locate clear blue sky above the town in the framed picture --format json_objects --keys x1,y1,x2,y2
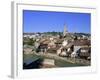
[{"x1": 23, "y1": 10, "x2": 91, "y2": 33}]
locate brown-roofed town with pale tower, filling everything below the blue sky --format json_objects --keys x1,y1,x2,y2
[{"x1": 23, "y1": 24, "x2": 91, "y2": 69}]
